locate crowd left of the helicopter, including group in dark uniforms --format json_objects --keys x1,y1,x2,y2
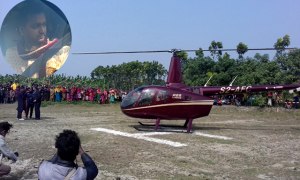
[{"x1": 0, "y1": 82, "x2": 127, "y2": 120}]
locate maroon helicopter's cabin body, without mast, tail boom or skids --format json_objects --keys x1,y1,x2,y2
[{"x1": 121, "y1": 86, "x2": 214, "y2": 120}]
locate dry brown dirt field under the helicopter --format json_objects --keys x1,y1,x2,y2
[{"x1": 0, "y1": 103, "x2": 300, "y2": 180}]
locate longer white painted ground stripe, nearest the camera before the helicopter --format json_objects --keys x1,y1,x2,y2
[{"x1": 91, "y1": 128, "x2": 187, "y2": 147}]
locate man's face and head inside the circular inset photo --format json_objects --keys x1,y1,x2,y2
[{"x1": 19, "y1": 13, "x2": 47, "y2": 48}]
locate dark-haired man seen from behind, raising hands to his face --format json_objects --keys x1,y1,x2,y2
[{"x1": 38, "y1": 130, "x2": 98, "y2": 180}]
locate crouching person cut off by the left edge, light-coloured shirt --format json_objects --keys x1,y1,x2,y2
[{"x1": 0, "y1": 122, "x2": 19, "y2": 177}]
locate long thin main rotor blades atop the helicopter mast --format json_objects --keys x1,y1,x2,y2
[{"x1": 72, "y1": 48, "x2": 295, "y2": 55}]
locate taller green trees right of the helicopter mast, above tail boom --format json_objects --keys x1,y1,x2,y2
[{"x1": 179, "y1": 35, "x2": 300, "y2": 86}]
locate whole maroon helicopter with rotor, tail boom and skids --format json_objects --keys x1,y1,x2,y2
[{"x1": 74, "y1": 48, "x2": 300, "y2": 133}]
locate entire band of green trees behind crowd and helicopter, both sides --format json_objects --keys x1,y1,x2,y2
[{"x1": 0, "y1": 35, "x2": 300, "y2": 91}]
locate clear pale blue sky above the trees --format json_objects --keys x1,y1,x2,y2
[{"x1": 0, "y1": 0, "x2": 300, "y2": 76}]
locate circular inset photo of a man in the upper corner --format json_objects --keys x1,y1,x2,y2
[{"x1": 0, "y1": 0, "x2": 72, "y2": 78}]
